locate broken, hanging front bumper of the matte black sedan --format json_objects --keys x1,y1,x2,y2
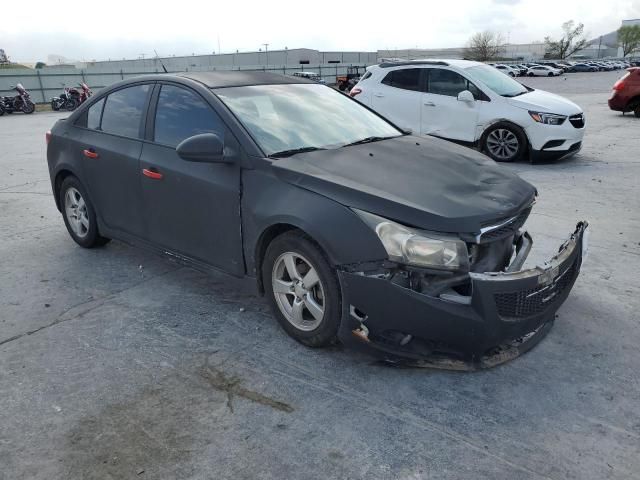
[{"x1": 339, "y1": 222, "x2": 588, "y2": 370}]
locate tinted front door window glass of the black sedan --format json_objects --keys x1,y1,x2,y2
[{"x1": 154, "y1": 85, "x2": 222, "y2": 147}]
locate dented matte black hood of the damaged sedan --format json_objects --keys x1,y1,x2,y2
[{"x1": 272, "y1": 136, "x2": 535, "y2": 233}]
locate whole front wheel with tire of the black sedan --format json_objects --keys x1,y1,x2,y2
[{"x1": 262, "y1": 230, "x2": 342, "y2": 347}]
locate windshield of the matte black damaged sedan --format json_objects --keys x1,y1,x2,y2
[{"x1": 214, "y1": 84, "x2": 402, "y2": 155}]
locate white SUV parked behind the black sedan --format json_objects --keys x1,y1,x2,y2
[{"x1": 350, "y1": 60, "x2": 584, "y2": 162}]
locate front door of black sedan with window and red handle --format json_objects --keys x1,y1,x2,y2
[{"x1": 140, "y1": 83, "x2": 244, "y2": 275}]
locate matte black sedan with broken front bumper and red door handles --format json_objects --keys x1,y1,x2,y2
[{"x1": 47, "y1": 70, "x2": 587, "y2": 368}]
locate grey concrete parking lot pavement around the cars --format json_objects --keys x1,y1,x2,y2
[{"x1": 0, "y1": 71, "x2": 640, "y2": 480}]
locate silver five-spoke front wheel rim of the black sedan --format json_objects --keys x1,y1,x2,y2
[{"x1": 271, "y1": 252, "x2": 325, "y2": 332}]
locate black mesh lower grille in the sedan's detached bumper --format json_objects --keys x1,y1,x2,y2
[{"x1": 494, "y1": 258, "x2": 578, "y2": 321}]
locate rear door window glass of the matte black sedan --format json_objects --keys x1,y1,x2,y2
[{"x1": 102, "y1": 85, "x2": 151, "y2": 138}]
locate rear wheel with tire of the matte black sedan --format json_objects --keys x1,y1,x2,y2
[{"x1": 59, "y1": 176, "x2": 109, "y2": 248}]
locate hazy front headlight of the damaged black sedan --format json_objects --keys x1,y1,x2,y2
[{"x1": 354, "y1": 209, "x2": 469, "y2": 271}]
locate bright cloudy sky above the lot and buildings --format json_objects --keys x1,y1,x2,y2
[{"x1": 0, "y1": 0, "x2": 640, "y2": 62}]
